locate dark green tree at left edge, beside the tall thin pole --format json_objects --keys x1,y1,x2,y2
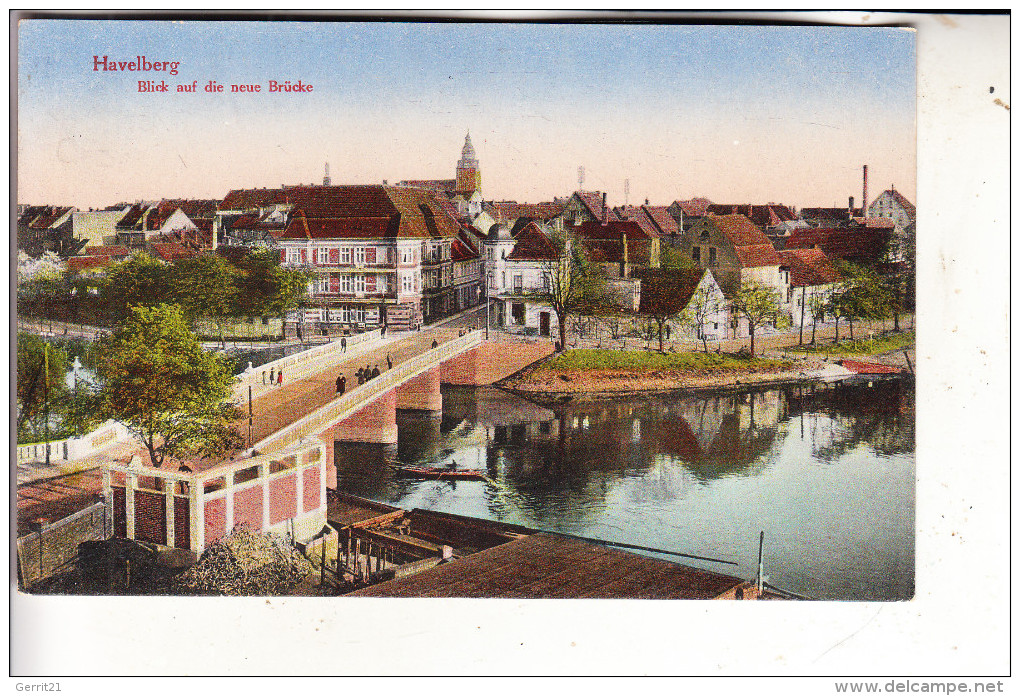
[{"x1": 17, "y1": 333, "x2": 67, "y2": 440}]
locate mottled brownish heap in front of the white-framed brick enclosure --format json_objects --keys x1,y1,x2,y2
[{"x1": 173, "y1": 525, "x2": 311, "y2": 596}]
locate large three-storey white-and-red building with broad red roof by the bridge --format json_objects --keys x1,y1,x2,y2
[{"x1": 277, "y1": 185, "x2": 466, "y2": 332}]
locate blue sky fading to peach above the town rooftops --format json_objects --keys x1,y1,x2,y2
[{"x1": 17, "y1": 19, "x2": 916, "y2": 209}]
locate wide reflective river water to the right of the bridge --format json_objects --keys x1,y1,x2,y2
[{"x1": 336, "y1": 381, "x2": 915, "y2": 600}]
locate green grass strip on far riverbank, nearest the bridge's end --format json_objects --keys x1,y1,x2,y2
[{"x1": 534, "y1": 349, "x2": 792, "y2": 377}]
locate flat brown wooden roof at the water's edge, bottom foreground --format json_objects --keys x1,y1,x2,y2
[{"x1": 348, "y1": 533, "x2": 744, "y2": 599}]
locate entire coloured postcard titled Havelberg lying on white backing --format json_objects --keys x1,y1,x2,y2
[{"x1": 11, "y1": 15, "x2": 1008, "y2": 674}]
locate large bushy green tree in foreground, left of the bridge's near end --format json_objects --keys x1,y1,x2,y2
[{"x1": 100, "y1": 304, "x2": 243, "y2": 466}]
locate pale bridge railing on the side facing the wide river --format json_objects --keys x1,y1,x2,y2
[{"x1": 252, "y1": 330, "x2": 486, "y2": 452}]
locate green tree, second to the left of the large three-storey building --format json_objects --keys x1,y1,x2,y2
[{"x1": 169, "y1": 254, "x2": 239, "y2": 348}]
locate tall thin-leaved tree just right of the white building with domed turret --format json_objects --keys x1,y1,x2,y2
[{"x1": 537, "y1": 231, "x2": 607, "y2": 350}]
